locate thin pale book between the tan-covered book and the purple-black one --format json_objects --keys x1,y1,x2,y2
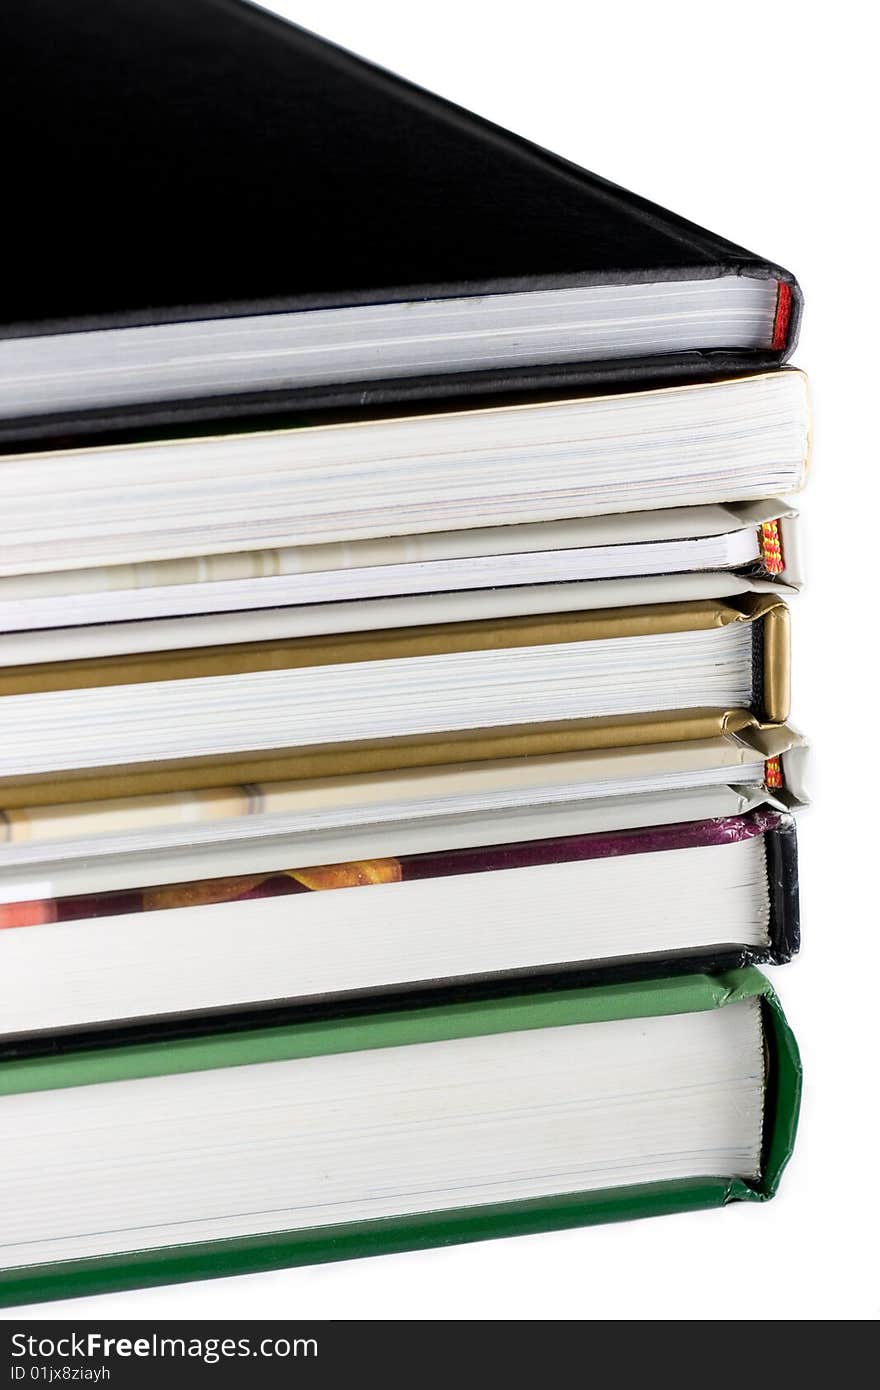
[{"x1": 0, "y1": 716, "x2": 808, "y2": 884}]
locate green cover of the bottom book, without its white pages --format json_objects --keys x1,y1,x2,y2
[{"x1": 0, "y1": 967, "x2": 801, "y2": 1307}]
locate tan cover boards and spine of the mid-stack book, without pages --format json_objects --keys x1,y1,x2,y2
[{"x1": 0, "y1": 595, "x2": 790, "y2": 810}]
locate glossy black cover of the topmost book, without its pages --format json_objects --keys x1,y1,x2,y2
[{"x1": 0, "y1": 0, "x2": 799, "y2": 438}]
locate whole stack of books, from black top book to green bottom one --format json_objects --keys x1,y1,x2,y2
[{"x1": 0, "y1": 0, "x2": 809, "y2": 1301}]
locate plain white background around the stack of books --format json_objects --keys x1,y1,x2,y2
[{"x1": 10, "y1": 0, "x2": 880, "y2": 1321}]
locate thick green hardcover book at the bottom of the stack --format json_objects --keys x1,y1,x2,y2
[{"x1": 0, "y1": 969, "x2": 801, "y2": 1304}]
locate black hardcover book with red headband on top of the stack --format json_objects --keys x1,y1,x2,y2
[{"x1": 0, "y1": 0, "x2": 801, "y2": 438}]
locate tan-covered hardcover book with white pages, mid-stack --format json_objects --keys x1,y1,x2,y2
[{"x1": 0, "y1": 595, "x2": 790, "y2": 808}]
